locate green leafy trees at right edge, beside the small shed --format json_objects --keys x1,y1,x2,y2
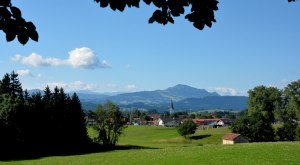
[{"x1": 231, "y1": 80, "x2": 300, "y2": 142}]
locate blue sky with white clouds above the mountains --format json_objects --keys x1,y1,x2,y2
[{"x1": 0, "y1": 0, "x2": 300, "y2": 95}]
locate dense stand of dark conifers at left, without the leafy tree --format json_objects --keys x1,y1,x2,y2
[{"x1": 0, "y1": 72, "x2": 88, "y2": 149}]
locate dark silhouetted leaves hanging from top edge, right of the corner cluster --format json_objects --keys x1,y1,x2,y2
[{"x1": 95, "y1": 0, "x2": 295, "y2": 30}]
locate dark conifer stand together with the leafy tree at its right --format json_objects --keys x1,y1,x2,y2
[{"x1": 0, "y1": 71, "x2": 125, "y2": 156}]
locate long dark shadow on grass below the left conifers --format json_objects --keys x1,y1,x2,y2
[{"x1": 0, "y1": 143, "x2": 158, "y2": 162}]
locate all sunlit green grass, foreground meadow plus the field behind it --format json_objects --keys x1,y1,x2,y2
[{"x1": 0, "y1": 126, "x2": 300, "y2": 165}]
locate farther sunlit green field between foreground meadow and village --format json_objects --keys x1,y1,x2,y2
[{"x1": 119, "y1": 126, "x2": 229, "y2": 148}]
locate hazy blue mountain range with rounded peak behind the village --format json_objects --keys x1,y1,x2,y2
[{"x1": 29, "y1": 84, "x2": 248, "y2": 112}]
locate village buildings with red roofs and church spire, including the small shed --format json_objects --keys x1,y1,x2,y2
[{"x1": 86, "y1": 101, "x2": 249, "y2": 144}]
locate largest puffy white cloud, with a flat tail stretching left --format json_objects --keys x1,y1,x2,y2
[{"x1": 11, "y1": 47, "x2": 111, "y2": 69}]
